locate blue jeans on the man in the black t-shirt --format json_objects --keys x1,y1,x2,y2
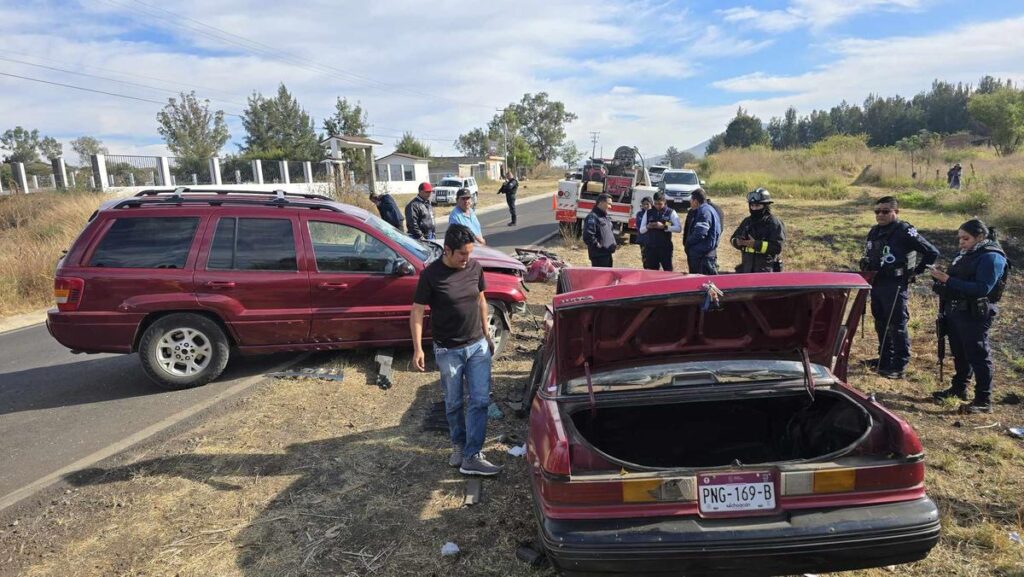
[{"x1": 434, "y1": 338, "x2": 490, "y2": 457}]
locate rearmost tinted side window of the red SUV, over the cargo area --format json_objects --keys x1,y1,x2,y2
[{"x1": 89, "y1": 216, "x2": 199, "y2": 269}]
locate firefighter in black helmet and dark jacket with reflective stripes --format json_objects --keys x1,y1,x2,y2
[{"x1": 729, "y1": 189, "x2": 785, "y2": 273}]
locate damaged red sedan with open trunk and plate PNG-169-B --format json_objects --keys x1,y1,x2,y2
[{"x1": 527, "y1": 269, "x2": 939, "y2": 575}]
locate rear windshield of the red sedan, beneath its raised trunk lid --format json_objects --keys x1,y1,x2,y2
[{"x1": 565, "y1": 359, "x2": 831, "y2": 395}]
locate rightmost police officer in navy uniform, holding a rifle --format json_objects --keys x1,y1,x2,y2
[{"x1": 931, "y1": 218, "x2": 1011, "y2": 414}]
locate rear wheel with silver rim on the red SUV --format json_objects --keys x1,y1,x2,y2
[{"x1": 138, "y1": 313, "x2": 230, "y2": 390}]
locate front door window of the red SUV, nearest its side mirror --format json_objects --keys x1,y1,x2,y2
[{"x1": 309, "y1": 222, "x2": 398, "y2": 273}]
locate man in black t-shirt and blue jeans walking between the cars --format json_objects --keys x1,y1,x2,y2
[{"x1": 409, "y1": 224, "x2": 502, "y2": 477}]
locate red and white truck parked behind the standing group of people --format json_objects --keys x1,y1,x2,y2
[{"x1": 554, "y1": 147, "x2": 657, "y2": 242}]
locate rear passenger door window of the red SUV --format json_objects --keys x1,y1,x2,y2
[{"x1": 207, "y1": 218, "x2": 298, "y2": 271}]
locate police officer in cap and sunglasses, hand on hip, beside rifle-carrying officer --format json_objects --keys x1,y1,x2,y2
[{"x1": 860, "y1": 197, "x2": 939, "y2": 379}]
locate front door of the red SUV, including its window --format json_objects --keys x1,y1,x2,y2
[{"x1": 303, "y1": 215, "x2": 419, "y2": 345}]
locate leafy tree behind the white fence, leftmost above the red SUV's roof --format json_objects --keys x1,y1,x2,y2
[{"x1": 157, "y1": 91, "x2": 231, "y2": 162}]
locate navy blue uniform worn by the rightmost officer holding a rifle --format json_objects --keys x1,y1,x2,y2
[{"x1": 942, "y1": 241, "x2": 1007, "y2": 405}]
